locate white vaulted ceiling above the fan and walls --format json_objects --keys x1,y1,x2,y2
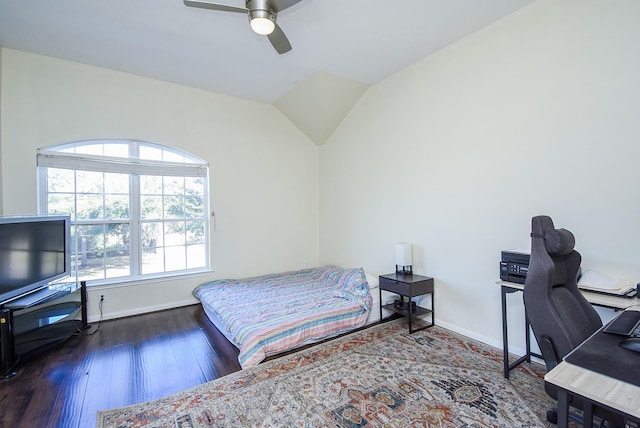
[{"x1": 0, "y1": 0, "x2": 533, "y2": 144}]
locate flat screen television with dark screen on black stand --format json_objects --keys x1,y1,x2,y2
[{"x1": 0, "y1": 216, "x2": 71, "y2": 303}]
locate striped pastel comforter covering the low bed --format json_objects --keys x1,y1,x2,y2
[{"x1": 193, "y1": 266, "x2": 372, "y2": 368}]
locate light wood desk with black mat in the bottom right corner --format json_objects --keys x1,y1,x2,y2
[{"x1": 544, "y1": 308, "x2": 640, "y2": 428}]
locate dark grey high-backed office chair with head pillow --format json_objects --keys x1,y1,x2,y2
[{"x1": 524, "y1": 216, "x2": 619, "y2": 426}]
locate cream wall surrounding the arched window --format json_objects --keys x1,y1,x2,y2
[{"x1": 0, "y1": 49, "x2": 318, "y2": 319}]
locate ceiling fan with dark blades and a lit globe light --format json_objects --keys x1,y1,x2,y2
[{"x1": 183, "y1": 0, "x2": 302, "y2": 54}]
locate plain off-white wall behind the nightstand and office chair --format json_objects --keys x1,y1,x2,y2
[{"x1": 320, "y1": 0, "x2": 640, "y2": 349}]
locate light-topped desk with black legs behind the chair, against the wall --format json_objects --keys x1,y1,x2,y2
[{"x1": 496, "y1": 281, "x2": 640, "y2": 379}]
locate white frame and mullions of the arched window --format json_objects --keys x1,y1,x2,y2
[{"x1": 37, "y1": 139, "x2": 211, "y2": 285}]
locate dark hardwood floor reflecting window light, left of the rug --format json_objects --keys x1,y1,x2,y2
[{"x1": 0, "y1": 305, "x2": 240, "y2": 428}]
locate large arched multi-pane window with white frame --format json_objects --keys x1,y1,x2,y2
[{"x1": 37, "y1": 140, "x2": 209, "y2": 283}]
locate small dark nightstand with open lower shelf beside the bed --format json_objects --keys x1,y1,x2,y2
[{"x1": 379, "y1": 273, "x2": 436, "y2": 334}]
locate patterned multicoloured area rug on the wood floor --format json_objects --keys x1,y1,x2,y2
[{"x1": 97, "y1": 320, "x2": 553, "y2": 428}]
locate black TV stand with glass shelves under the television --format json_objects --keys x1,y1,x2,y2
[{"x1": 0, "y1": 281, "x2": 89, "y2": 379}]
